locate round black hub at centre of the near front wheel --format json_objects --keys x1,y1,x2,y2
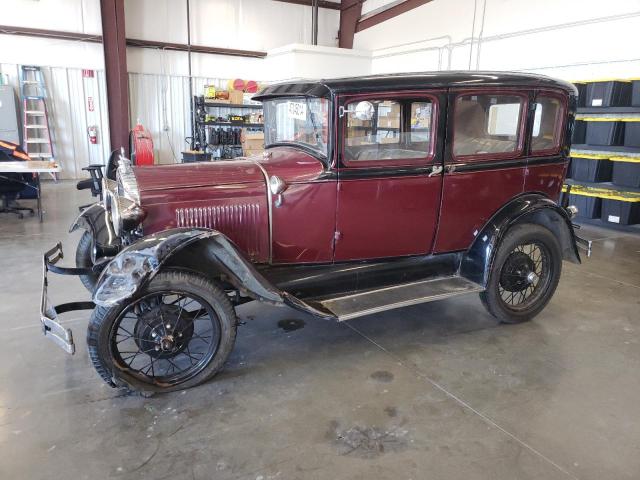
[{"x1": 134, "y1": 304, "x2": 193, "y2": 358}]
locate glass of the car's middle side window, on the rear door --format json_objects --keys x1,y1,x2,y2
[{"x1": 453, "y1": 94, "x2": 524, "y2": 157}]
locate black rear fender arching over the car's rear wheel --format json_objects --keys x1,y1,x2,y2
[{"x1": 460, "y1": 193, "x2": 581, "y2": 286}]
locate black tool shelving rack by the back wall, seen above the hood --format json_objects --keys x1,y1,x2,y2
[{"x1": 193, "y1": 96, "x2": 264, "y2": 160}]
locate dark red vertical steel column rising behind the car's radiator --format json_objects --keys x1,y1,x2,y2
[{"x1": 100, "y1": 0, "x2": 129, "y2": 156}]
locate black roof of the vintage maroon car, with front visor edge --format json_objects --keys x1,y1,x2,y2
[{"x1": 253, "y1": 71, "x2": 578, "y2": 100}]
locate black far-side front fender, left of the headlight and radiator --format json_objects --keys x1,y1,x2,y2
[{"x1": 69, "y1": 202, "x2": 121, "y2": 263}]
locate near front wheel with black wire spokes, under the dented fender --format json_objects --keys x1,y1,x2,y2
[{"x1": 87, "y1": 270, "x2": 237, "y2": 392}]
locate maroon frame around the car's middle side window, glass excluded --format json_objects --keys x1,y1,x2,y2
[{"x1": 449, "y1": 88, "x2": 531, "y2": 163}]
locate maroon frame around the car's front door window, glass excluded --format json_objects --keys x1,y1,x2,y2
[{"x1": 339, "y1": 90, "x2": 442, "y2": 170}]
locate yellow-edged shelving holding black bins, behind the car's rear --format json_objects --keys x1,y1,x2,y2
[{"x1": 564, "y1": 78, "x2": 640, "y2": 232}]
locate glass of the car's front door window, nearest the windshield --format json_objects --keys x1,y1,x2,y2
[{"x1": 344, "y1": 99, "x2": 433, "y2": 163}]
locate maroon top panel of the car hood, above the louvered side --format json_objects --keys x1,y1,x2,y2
[{"x1": 134, "y1": 159, "x2": 265, "y2": 194}]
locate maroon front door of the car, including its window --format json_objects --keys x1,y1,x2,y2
[{"x1": 334, "y1": 91, "x2": 445, "y2": 261}]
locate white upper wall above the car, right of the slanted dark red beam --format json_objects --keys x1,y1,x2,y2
[{"x1": 354, "y1": 0, "x2": 640, "y2": 80}]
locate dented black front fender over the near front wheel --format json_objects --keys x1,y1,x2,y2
[{"x1": 93, "y1": 228, "x2": 283, "y2": 306}]
